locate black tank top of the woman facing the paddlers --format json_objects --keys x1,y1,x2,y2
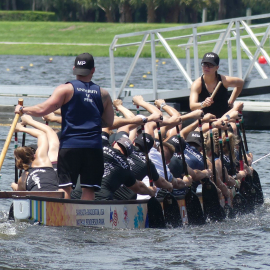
[{"x1": 199, "y1": 74, "x2": 229, "y2": 118}]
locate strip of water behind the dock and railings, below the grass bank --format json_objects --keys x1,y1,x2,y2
[{"x1": 0, "y1": 55, "x2": 270, "y2": 97}]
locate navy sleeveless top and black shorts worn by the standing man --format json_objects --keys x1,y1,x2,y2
[{"x1": 57, "y1": 80, "x2": 104, "y2": 190}]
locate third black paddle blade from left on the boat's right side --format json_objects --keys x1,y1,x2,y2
[{"x1": 185, "y1": 188, "x2": 205, "y2": 225}]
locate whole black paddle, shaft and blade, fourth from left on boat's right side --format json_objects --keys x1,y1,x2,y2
[{"x1": 200, "y1": 122, "x2": 226, "y2": 221}]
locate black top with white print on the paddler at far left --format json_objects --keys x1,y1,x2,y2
[{"x1": 26, "y1": 167, "x2": 59, "y2": 191}]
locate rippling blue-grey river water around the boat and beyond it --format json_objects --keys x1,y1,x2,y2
[{"x1": 0, "y1": 56, "x2": 270, "y2": 270}]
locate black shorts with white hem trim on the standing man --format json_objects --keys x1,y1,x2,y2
[{"x1": 57, "y1": 148, "x2": 104, "y2": 191}]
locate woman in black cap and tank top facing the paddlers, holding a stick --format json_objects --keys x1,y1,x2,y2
[{"x1": 189, "y1": 52, "x2": 244, "y2": 118}]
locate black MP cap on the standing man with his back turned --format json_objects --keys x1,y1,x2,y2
[{"x1": 73, "y1": 53, "x2": 95, "y2": 76}]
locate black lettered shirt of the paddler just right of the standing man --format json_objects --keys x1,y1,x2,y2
[{"x1": 95, "y1": 146, "x2": 136, "y2": 200}]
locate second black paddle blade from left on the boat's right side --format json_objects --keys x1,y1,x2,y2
[{"x1": 163, "y1": 193, "x2": 183, "y2": 228}]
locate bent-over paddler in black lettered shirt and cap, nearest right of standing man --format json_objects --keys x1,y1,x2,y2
[{"x1": 96, "y1": 137, "x2": 156, "y2": 200}]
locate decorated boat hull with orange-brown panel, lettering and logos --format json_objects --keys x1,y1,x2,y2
[{"x1": 13, "y1": 194, "x2": 193, "y2": 229}]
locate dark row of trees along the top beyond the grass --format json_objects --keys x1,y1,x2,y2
[{"x1": 0, "y1": 0, "x2": 270, "y2": 23}]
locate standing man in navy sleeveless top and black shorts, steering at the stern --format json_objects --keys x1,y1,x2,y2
[{"x1": 15, "y1": 53, "x2": 114, "y2": 200}]
